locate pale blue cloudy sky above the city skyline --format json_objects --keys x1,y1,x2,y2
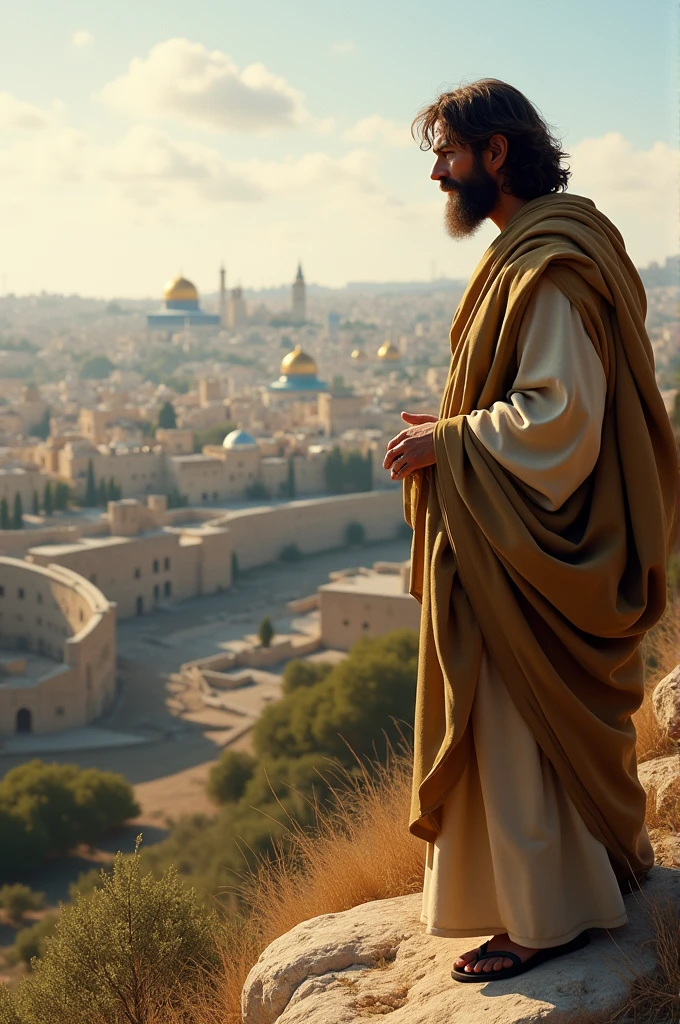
[{"x1": 0, "y1": 0, "x2": 678, "y2": 298}]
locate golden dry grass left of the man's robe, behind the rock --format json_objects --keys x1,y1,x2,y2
[{"x1": 167, "y1": 750, "x2": 424, "y2": 1024}]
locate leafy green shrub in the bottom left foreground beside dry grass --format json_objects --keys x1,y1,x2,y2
[{"x1": 5, "y1": 841, "x2": 219, "y2": 1024}]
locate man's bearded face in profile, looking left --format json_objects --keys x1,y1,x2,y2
[{"x1": 430, "y1": 136, "x2": 500, "y2": 239}]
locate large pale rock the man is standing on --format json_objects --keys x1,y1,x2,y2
[{"x1": 242, "y1": 867, "x2": 680, "y2": 1024}]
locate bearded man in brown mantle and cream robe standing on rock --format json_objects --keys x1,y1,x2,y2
[{"x1": 384, "y1": 80, "x2": 678, "y2": 981}]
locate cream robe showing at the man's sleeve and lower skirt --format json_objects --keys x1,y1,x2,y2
[{"x1": 421, "y1": 280, "x2": 648, "y2": 948}]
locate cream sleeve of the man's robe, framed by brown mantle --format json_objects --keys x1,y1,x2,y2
[{"x1": 467, "y1": 279, "x2": 606, "y2": 511}]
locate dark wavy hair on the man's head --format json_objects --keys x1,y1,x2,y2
[{"x1": 411, "y1": 78, "x2": 570, "y2": 200}]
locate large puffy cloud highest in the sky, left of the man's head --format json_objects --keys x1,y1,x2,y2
[{"x1": 100, "y1": 39, "x2": 308, "y2": 131}]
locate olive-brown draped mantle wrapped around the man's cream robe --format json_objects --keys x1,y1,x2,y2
[{"x1": 405, "y1": 195, "x2": 678, "y2": 882}]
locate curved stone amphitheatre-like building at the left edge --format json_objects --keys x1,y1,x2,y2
[{"x1": 0, "y1": 557, "x2": 116, "y2": 736}]
